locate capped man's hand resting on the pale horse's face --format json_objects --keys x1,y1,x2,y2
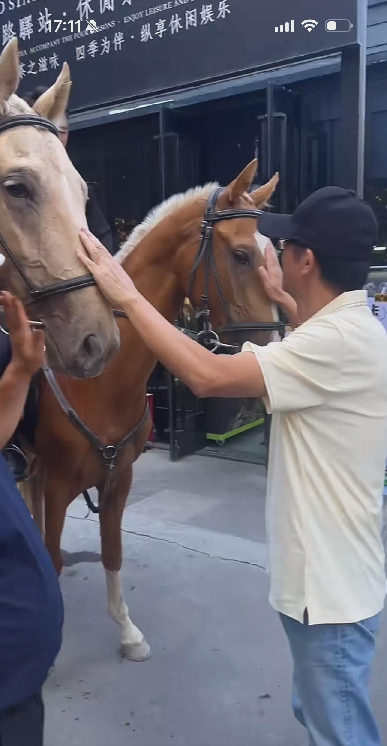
[{"x1": 78, "y1": 229, "x2": 138, "y2": 308}]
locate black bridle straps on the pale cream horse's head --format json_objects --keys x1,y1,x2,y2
[{"x1": 0, "y1": 115, "x2": 95, "y2": 306}]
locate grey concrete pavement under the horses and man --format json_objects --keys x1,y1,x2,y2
[{"x1": 45, "y1": 451, "x2": 387, "y2": 746}]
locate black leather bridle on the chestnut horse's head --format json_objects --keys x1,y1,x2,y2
[{"x1": 189, "y1": 187, "x2": 285, "y2": 351}]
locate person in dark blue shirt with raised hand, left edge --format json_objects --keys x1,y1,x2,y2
[{"x1": 0, "y1": 293, "x2": 63, "y2": 746}]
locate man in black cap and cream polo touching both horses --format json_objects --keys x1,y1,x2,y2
[{"x1": 81, "y1": 187, "x2": 387, "y2": 746}]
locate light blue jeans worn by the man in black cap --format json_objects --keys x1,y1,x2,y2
[{"x1": 280, "y1": 614, "x2": 382, "y2": 746}]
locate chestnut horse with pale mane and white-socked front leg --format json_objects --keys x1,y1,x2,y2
[{"x1": 28, "y1": 161, "x2": 278, "y2": 661}]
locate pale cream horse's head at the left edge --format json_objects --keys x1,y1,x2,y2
[{"x1": 0, "y1": 39, "x2": 119, "y2": 378}]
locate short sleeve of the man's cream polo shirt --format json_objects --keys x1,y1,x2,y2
[{"x1": 242, "y1": 319, "x2": 344, "y2": 414}]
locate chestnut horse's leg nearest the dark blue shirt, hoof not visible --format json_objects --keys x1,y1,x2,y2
[{"x1": 44, "y1": 479, "x2": 71, "y2": 575}]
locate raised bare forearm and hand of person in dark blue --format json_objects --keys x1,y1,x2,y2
[{"x1": 0, "y1": 293, "x2": 44, "y2": 450}]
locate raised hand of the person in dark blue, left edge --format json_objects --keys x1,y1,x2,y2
[{"x1": 0, "y1": 291, "x2": 46, "y2": 377}]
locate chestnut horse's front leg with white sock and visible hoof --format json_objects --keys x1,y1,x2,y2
[{"x1": 99, "y1": 466, "x2": 151, "y2": 661}]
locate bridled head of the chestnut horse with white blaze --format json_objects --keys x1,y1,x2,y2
[{"x1": 180, "y1": 160, "x2": 278, "y2": 343}]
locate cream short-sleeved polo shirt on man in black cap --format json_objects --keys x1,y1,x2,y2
[{"x1": 243, "y1": 290, "x2": 387, "y2": 624}]
